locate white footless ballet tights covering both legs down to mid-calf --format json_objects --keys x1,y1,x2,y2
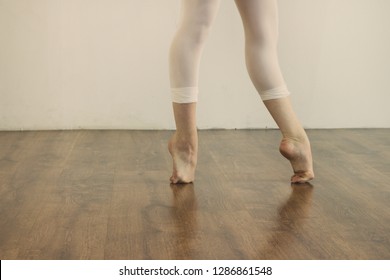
[{"x1": 170, "y1": 0, "x2": 289, "y2": 103}]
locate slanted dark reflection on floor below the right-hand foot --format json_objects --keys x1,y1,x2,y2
[{"x1": 258, "y1": 183, "x2": 313, "y2": 259}]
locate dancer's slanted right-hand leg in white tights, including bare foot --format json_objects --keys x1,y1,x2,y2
[{"x1": 235, "y1": 0, "x2": 314, "y2": 183}]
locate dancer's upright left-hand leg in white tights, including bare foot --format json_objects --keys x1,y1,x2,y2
[{"x1": 168, "y1": 0, "x2": 220, "y2": 184}]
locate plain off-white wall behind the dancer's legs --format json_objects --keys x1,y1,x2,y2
[{"x1": 0, "y1": 0, "x2": 390, "y2": 130}]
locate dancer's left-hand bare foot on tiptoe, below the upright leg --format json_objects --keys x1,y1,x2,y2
[{"x1": 168, "y1": 133, "x2": 197, "y2": 184}]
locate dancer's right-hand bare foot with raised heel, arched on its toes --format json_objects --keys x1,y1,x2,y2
[{"x1": 279, "y1": 138, "x2": 314, "y2": 183}]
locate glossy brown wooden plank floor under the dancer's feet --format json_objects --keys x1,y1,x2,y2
[{"x1": 0, "y1": 129, "x2": 390, "y2": 259}]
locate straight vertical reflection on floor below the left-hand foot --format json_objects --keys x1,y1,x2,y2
[{"x1": 171, "y1": 184, "x2": 198, "y2": 259}]
